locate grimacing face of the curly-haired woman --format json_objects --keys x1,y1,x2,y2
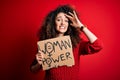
[{"x1": 55, "y1": 12, "x2": 69, "y2": 35}]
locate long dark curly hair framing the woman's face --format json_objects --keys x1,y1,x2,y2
[{"x1": 38, "y1": 5, "x2": 80, "y2": 47}]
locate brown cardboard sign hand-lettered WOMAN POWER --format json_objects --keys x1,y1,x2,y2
[{"x1": 37, "y1": 36, "x2": 74, "y2": 70}]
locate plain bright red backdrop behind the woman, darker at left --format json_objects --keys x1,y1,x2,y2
[{"x1": 0, "y1": 0, "x2": 120, "y2": 80}]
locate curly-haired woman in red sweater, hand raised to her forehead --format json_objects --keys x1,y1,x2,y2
[{"x1": 31, "y1": 5, "x2": 102, "y2": 80}]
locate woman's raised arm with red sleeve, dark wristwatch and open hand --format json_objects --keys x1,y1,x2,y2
[{"x1": 66, "y1": 11, "x2": 103, "y2": 55}]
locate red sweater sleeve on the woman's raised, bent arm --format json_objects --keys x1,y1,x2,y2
[{"x1": 80, "y1": 39, "x2": 103, "y2": 55}]
